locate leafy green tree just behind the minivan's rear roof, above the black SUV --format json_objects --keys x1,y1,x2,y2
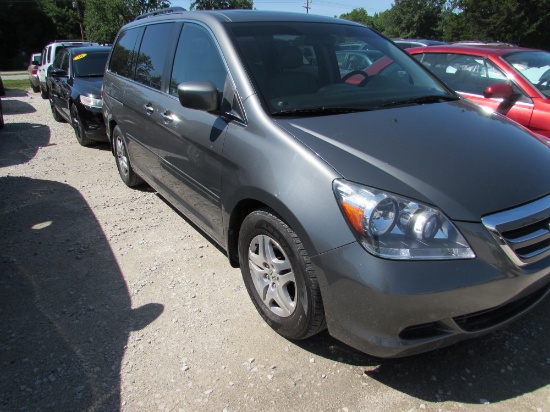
[{"x1": 84, "y1": 0, "x2": 170, "y2": 43}]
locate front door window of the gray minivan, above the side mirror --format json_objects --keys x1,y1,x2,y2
[{"x1": 170, "y1": 24, "x2": 227, "y2": 96}]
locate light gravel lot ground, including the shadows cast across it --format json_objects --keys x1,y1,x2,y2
[{"x1": 0, "y1": 91, "x2": 550, "y2": 412}]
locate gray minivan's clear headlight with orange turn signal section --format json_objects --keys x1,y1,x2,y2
[{"x1": 334, "y1": 180, "x2": 475, "y2": 260}]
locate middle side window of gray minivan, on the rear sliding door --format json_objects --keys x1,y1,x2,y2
[{"x1": 135, "y1": 23, "x2": 175, "y2": 90}]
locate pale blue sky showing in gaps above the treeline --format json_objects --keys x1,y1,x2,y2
[{"x1": 171, "y1": 0, "x2": 393, "y2": 17}]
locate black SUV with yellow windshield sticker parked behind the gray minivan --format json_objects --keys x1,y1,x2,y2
[{"x1": 48, "y1": 46, "x2": 111, "y2": 146}]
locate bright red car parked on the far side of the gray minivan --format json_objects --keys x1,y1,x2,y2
[{"x1": 408, "y1": 45, "x2": 550, "y2": 139}]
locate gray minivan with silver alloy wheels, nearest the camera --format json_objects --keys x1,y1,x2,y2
[{"x1": 103, "y1": 9, "x2": 550, "y2": 357}]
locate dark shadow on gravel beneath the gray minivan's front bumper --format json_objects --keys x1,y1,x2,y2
[{"x1": 297, "y1": 298, "x2": 550, "y2": 405}]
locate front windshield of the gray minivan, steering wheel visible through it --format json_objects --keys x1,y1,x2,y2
[{"x1": 229, "y1": 22, "x2": 458, "y2": 116}]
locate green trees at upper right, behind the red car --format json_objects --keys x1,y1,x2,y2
[{"x1": 340, "y1": 0, "x2": 550, "y2": 49}]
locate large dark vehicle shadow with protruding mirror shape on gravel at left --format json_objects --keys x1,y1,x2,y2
[{"x1": 0, "y1": 176, "x2": 163, "y2": 411}]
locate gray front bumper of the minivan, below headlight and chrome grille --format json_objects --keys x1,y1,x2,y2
[{"x1": 312, "y1": 220, "x2": 550, "y2": 357}]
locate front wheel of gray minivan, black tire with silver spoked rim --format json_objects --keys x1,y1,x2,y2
[{"x1": 239, "y1": 209, "x2": 326, "y2": 340}]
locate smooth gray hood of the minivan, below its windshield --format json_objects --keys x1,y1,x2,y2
[{"x1": 277, "y1": 100, "x2": 550, "y2": 221}]
